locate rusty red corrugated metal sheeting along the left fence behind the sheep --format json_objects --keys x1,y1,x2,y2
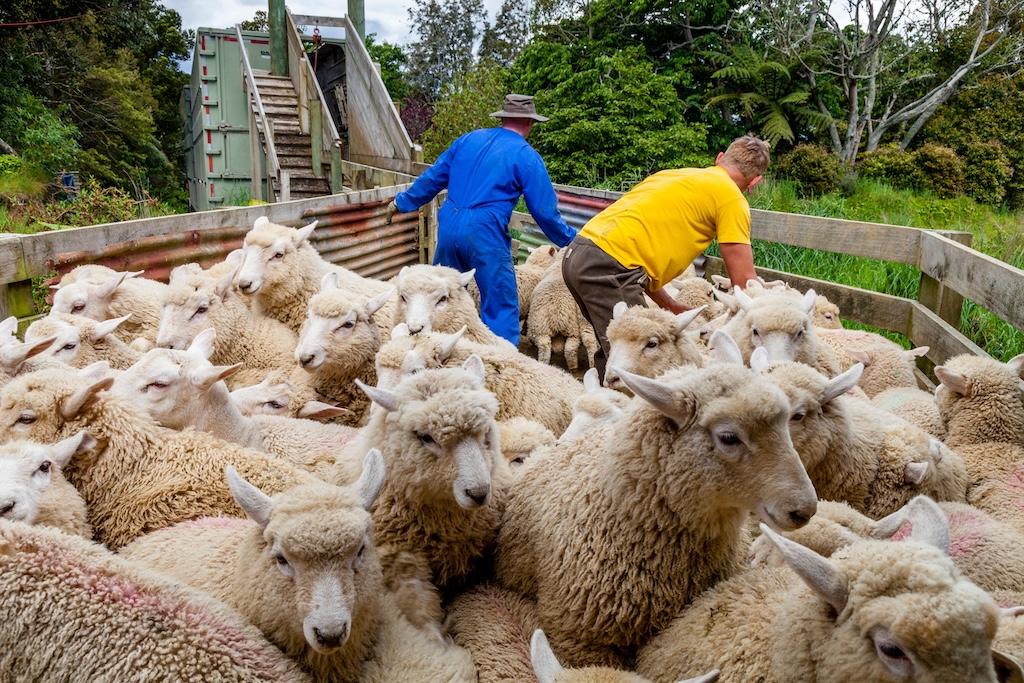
[{"x1": 46, "y1": 201, "x2": 420, "y2": 294}]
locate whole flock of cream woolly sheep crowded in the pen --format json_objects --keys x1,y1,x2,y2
[{"x1": 0, "y1": 218, "x2": 1024, "y2": 683}]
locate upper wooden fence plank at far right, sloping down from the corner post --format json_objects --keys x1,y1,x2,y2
[{"x1": 921, "y1": 233, "x2": 1024, "y2": 330}]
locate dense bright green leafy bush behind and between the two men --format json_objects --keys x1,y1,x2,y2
[{"x1": 512, "y1": 42, "x2": 710, "y2": 185}]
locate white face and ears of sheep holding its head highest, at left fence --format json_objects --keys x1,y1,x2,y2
[{"x1": 234, "y1": 218, "x2": 316, "y2": 296}]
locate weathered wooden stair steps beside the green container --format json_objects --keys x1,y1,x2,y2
[{"x1": 250, "y1": 71, "x2": 331, "y2": 201}]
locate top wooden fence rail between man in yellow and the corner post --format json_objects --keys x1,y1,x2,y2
[{"x1": 751, "y1": 209, "x2": 927, "y2": 266}]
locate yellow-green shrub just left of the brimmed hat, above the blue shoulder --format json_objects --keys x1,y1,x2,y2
[{"x1": 422, "y1": 62, "x2": 507, "y2": 163}]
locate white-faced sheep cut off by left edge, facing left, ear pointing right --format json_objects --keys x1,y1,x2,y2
[{"x1": 0, "y1": 430, "x2": 96, "y2": 539}]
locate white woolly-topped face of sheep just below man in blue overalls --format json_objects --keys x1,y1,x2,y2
[{"x1": 395, "y1": 265, "x2": 475, "y2": 335}]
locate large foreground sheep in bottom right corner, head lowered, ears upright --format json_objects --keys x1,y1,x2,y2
[{"x1": 637, "y1": 507, "x2": 1021, "y2": 683}]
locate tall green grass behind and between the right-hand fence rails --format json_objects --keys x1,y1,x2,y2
[{"x1": 751, "y1": 180, "x2": 1024, "y2": 360}]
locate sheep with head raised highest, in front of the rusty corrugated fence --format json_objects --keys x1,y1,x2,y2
[{"x1": 234, "y1": 216, "x2": 389, "y2": 334}]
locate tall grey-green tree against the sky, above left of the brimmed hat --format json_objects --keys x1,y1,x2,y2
[{"x1": 408, "y1": 0, "x2": 485, "y2": 99}]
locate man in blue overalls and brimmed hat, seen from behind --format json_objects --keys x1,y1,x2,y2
[{"x1": 387, "y1": 94, "x2": 577, "y2": 344}]
